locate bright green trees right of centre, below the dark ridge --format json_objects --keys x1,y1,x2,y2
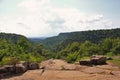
[{"x1": 57, "y1": 38, "x2": 120, "y2": 63}]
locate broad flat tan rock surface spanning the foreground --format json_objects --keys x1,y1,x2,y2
[{"x1": 0, "y1": 59, "x2": 120, "y2": 80}]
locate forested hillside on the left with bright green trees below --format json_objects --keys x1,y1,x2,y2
[{"x1": 0, "y1": 33, "x2": 44, "y2": 65}]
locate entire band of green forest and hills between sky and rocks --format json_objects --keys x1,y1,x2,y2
[{"x1": 0, "y1": 28, "x2": 120, "y2": 65}]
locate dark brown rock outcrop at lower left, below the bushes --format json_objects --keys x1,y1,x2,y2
[{"x1": 0, "y1": 61, "x2": 39, "y2": 79}]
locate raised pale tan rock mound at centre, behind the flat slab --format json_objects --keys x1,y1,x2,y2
[{"x1": 40, "y1": 59, "x2": 76, "y2": 70}]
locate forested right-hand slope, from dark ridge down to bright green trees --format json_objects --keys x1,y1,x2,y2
[{"x1": 41, "y1": 28, "x2": 120, "y2": 62}]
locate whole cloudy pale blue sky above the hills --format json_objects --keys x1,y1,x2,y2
[{"x1": 0, "y1": 0, "x2": 120, "y2": 37}]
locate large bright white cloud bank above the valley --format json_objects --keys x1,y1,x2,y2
[{"x1": 0, "y1": 0, "x2": 116, "y2": 37}]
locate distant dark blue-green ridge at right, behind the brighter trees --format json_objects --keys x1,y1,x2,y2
[{"x1": 42, "y1": 28, "x2": 120, "y2": 49}]
